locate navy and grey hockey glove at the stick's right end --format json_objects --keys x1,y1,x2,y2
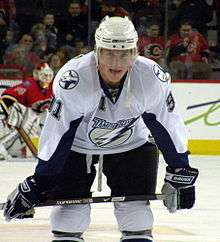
[{"x1": 162, "y1": 166, "x2": 199, "y2": 213}]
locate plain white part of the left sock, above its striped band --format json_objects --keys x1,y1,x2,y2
[{"x1": 50, "y1": 204, "x2": 91, "y2": 233}]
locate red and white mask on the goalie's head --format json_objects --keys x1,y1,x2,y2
[{"x1": 33, "y1": 63, "x2": 54, "y2": 88}]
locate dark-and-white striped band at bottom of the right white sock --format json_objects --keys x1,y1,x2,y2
[{"x1": 120, "y1": 230, "x2": 153, "y2": 242}]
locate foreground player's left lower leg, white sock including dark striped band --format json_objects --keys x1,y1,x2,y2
[{"x1": 50, "y1": 204, "x2": 91, "y2": 242}]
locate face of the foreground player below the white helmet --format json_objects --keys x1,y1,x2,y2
[{"x1": 99, "y1": 49, "x2": 133, "y2": 86}]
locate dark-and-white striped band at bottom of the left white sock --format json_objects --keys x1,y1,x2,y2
[{"x1": 52, "y1": 231, "x2": 84, "y2": 242}]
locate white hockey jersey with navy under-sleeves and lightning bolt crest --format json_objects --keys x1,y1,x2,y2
[{"x1": 38, "y1": 52, "x2": 188, "y2": 176}]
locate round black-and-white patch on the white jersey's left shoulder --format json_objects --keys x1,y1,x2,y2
[{"x1": 59, "y1": 70, "x2": 79, "y2": 90}]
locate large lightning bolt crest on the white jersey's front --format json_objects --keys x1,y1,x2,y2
[{"x1": 89, "y1": 117, "x2": 138, "y2": 148}]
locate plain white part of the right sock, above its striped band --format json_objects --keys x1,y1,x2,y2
[{"x1": 114, "y1": 201, "x2": 153, "y2": 231}]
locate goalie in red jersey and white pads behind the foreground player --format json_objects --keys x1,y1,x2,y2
[{"x1": 0, "y1": 63, "x2": 53, "y2": 159}]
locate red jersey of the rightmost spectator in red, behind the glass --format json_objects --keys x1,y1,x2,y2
[{"x1": 167, "y1": 31, "x2": 208, "y2": 62}]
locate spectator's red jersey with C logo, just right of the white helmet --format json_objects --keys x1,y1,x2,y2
[{"x1": 137, "y1": 36, "x2": 165, "y2": 61}]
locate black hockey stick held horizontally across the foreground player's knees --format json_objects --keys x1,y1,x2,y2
[{"x1": 0, "y1": 194, "x2": 165, "y2": 210}]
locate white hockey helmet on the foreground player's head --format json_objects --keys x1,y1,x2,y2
[{"x1": 95, "y1": 16, "x2": 138, "y2": 52}]
